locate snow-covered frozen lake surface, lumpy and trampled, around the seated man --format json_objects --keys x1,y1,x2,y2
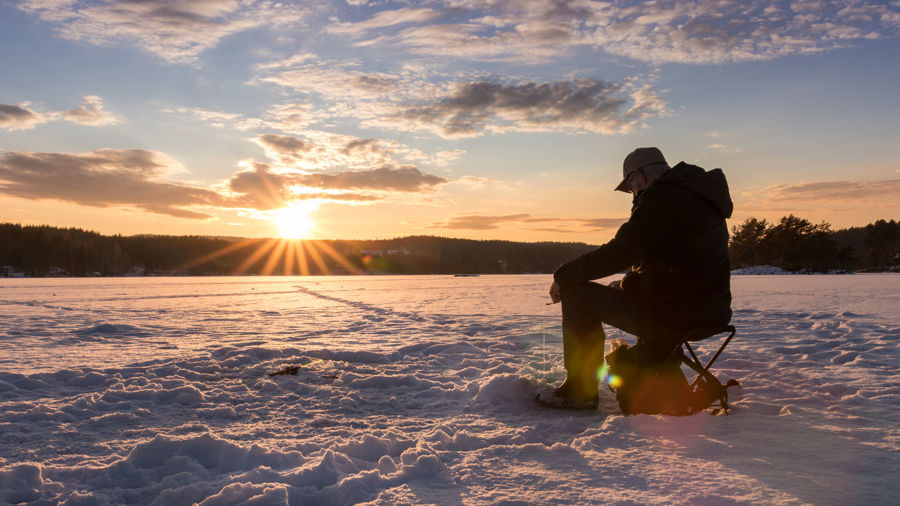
[{"x1": 0, "y1": 274, "x2": 900, "y2": 505}]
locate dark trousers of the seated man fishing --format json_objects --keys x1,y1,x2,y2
[{"x1": 560, "y1": 282, "x2": 681, "y2": 393}]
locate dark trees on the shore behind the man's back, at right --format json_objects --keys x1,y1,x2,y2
[{"x1": 729, "y1": 215, "x2": 900, "y2": 272}]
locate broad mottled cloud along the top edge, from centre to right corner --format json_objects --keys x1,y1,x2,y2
[{"x1": 331, "y1": 0, "x2": 900, "y2": 64}]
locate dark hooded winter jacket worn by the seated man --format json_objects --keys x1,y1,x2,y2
[{"x1": 553, "y1": 162, "x2": 733, "y2": 331}]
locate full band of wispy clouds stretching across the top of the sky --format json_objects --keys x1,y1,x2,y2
[{"x1": 19, "y1": 0, "x2": 900, "y2": 64}]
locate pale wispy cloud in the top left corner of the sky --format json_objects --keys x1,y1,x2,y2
[{"x1": 20, "y1": 0, "x2": 301, "y2": 63}]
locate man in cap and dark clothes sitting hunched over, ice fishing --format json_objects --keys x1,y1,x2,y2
[{"x1": 538, "y1": 147, "x2": 732, "y2": 409}]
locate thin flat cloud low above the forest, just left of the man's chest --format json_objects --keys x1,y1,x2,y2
[{"x1": 432, "y1": 213, "x2": 626, "y2": 233}]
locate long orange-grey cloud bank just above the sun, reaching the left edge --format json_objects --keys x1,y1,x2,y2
[{"x1": 0, "y1": 144, "x2": 449, "y2": 219}]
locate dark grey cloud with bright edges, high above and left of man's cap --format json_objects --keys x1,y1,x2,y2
[{"x1": 376, "y1": 79, "x2": 666, "y2": 138}]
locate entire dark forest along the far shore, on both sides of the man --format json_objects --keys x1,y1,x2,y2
[{"x1": 0, "y1": 215, "x2": 900, "y2": 277}]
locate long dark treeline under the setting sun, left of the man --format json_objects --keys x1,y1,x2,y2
[{"x1": 0, "y1": 223, "x2": 593, "y2": 276}]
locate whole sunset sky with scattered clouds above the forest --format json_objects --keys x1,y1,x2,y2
[{"x1": 0, "y1": 0, "x2": 900, "y2": 244}]
